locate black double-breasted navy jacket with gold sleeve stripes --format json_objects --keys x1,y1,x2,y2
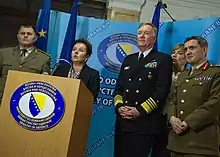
[{"x1": 114, "y1": 50, "x2": 172, "y2": 134}]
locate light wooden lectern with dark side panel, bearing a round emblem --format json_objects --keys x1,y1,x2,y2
[{"x1": 0, "y1": 70, "x2": 93, "y2": 157}]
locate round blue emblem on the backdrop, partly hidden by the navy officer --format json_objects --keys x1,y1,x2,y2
[{"x1": 97, "y1": 33, "x2": 139, "y2": 73}]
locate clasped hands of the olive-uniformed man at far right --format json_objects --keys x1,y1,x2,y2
[{"x1": 170, "y1": 116, "x2": 189, "y2": 134}]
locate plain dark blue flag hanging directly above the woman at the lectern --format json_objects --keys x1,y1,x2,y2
[{"x1": 59, "y1": 0, "x2": 79, "y2": 63}]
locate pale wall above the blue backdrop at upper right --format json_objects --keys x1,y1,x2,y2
[{"x1": 140, "y1": 0, "x2": 220, "y2": 21}]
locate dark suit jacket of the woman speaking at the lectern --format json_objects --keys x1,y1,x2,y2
[{"x1": 52, "y1": 63, "x2": 100, "y2": 101}]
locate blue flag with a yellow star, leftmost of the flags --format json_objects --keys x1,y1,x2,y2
[{"x1": 35, "y1": 0, "x2": 51, "y2": 52}]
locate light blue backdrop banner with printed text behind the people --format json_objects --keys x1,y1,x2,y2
[{"x1": 48, "y1": 11, "x2": 220, "y2": 157}]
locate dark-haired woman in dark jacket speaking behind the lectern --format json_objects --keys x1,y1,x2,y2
[{"x1": 52, "y1": 39, "x2": 100, "y2": 101}]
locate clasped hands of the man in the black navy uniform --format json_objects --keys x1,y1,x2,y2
[{"x1": 118, "y1": 106, "x2": 140, "y2": 120}]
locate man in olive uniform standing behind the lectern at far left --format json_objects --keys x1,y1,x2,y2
[{"x1": 0, "y1": 25, "x2": 50, "y2": 102}]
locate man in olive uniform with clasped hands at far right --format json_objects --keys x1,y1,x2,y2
[{"x1": 168, "y1": 36, "x2": 220, "y2": 157}]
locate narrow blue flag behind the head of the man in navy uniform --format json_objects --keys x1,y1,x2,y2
[{"x1": 152, "y1": 1, "x2": 162, "y2": 51}]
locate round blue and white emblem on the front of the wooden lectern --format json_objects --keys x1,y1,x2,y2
[{"x1": 10, "y1": 81, "x2": 65, "y2": 131}]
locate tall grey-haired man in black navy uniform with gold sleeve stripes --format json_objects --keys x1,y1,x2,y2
[{"x1": 114, "y1": 23, "x2": 172, "y2": 157}]
